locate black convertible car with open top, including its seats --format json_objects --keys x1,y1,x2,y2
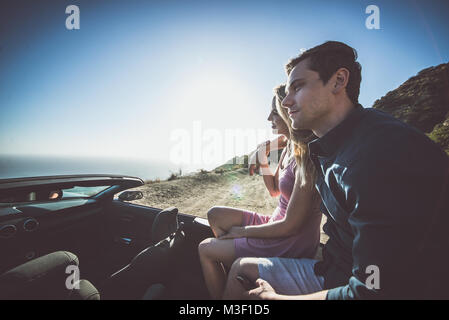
[{"x1": 0, "y1": 175, "x2": 213, "y2": 299}]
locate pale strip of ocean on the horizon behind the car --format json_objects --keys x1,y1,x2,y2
[{"x1": 0, "y1": 155, "x2": 187, "y2": 180}]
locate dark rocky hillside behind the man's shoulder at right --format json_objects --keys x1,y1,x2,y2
[{"x1": 373, "y1": 63, "x2": 449, "y2": 154}]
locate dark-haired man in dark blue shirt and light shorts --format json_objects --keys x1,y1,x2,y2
[{"x1": 224, "y1": 41, "x2": 449, "y2": 299}]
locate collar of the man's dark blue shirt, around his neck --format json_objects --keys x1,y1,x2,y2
[{"x1": 309, "y1": 103, "x2": 364, "y2": 157}]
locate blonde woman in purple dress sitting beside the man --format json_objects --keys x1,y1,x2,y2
[{"x1": 198, "y1": 85, "x2": 321, "y2": 299}]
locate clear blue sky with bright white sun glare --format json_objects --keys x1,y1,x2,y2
[{"x1": 0, "y1": 0, "x2": 449, "y2": 168}]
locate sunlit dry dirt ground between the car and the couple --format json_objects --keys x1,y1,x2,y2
[{"x1": 128, "y1": 169, "x2": 327, "y2": 242}]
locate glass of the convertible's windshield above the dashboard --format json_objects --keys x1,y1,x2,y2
[{"x1": 0, "y1": 186, "x2": 111, "y2": 203}]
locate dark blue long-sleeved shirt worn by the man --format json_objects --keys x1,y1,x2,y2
[{"x1": 309, "y1": 105, "x2": 449, "y2": 299}]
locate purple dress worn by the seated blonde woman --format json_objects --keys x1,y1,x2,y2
[{"x1": 234, "y1": 158, "x2": 322, "y2": 258}]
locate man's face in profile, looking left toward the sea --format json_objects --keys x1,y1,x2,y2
[{"x1": 282, "y1": 59, "x2": 332, "y2": 131}]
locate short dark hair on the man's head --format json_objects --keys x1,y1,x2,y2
[{"x1": 285, "y1": 41, "x2": 362, "y2": 104}]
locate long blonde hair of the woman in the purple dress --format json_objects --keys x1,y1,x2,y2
[{"x1": 273, "y1": 84, "x2": 316, "y2": 187}]
